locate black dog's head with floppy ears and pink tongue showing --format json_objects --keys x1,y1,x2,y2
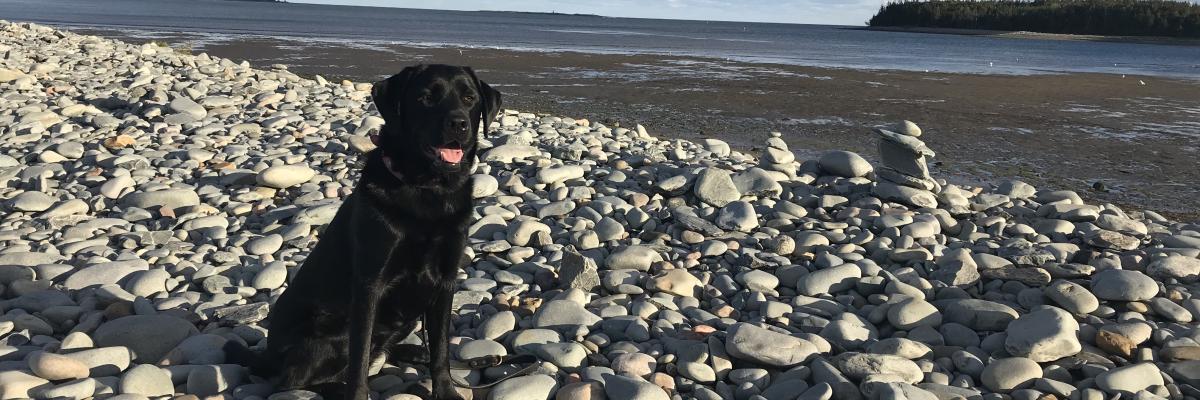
[{"x1": 371, "y1": 65, "x2": 500, "y2": 174}]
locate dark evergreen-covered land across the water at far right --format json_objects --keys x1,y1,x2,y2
[{"x1": 868, "y1": 0, "x2": 1200, "y2": 38}]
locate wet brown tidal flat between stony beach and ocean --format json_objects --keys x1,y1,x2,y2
[{"x1": 77, "y1": 29, "x2": 1200, "y2": 220}]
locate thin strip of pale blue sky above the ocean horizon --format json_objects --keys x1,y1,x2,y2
[{"x1": 289, "y1": 0, "x2": 881, "y2": 25}]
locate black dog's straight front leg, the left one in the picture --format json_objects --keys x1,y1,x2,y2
[{"x1": 346, "y1": 279, "x2": 379, "y2": 400}]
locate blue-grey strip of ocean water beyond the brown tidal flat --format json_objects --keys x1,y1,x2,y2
[{"x1": 0, "y1": 0, "x2": 1200, "y2": 79}]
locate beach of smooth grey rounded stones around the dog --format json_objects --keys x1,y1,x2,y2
[{"x1": 0, "y1": 22, "x2": 1200, "y2": 400}]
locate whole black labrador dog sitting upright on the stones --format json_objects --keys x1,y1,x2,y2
[{"x1": 229, "y1": 65, "x2": 500, "y2": 399}]
